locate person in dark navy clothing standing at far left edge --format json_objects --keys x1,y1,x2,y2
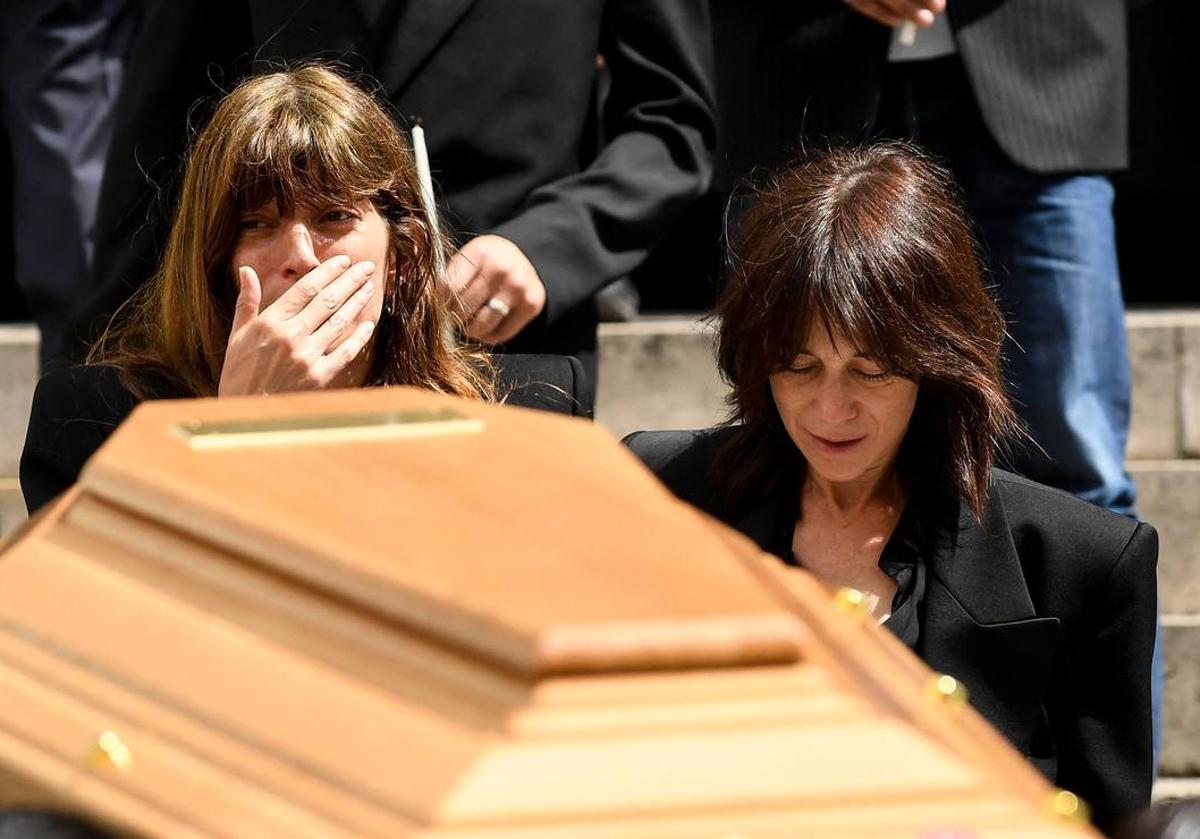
[{"x1": 0, "y1": 0, "x2": 140, "y2": 365}]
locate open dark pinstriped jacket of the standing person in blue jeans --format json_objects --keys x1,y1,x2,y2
[{"x1": 713, "y1": 0, "x2": 1138, "y2": 179}]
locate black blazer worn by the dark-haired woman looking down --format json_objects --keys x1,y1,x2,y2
[{"x1": 625, "y1": 429, "x2": 1158, "y2": 825}]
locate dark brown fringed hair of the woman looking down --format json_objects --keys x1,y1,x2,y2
[{"x1": 715, "y1": 144, "x2": 1020, "y2": 517}]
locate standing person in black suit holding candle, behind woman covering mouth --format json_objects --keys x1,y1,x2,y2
[{"x1": 63, "y1": 0, "x2": 715, "y2": 408}]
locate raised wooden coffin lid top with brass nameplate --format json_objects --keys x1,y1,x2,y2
[{"x1": 80, "y1": 388, "x2": 803, "y2": 675}]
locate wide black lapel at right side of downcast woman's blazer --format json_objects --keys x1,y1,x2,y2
[{"x1": 918, "y1": 489, "x2": 1060, "y2": 754}]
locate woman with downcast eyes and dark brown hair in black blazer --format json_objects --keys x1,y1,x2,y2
[{"x1": 626, "y1": 145, "x2": 1158, "y2": 825}]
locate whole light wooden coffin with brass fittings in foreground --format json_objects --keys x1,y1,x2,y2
[{"x1": 0, "y1": 389, "x2": 1096, "y2": 839}]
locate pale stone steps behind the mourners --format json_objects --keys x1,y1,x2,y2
[{"x1": 0, "y1": 310, "x2": 1200, "y2": 797}]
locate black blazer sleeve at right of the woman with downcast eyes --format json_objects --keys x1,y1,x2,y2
[{"x1": 1050, "y1": 525, "x2": 1158, "y2": 827}]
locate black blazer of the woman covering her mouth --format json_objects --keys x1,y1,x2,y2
[{"x1": 20, "y1": 354, "x2": 587, "y2": 514}]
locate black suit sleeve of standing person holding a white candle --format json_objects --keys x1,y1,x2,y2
[{"x1": 493, "y1": 0, "x2": 716, "y2": 323}]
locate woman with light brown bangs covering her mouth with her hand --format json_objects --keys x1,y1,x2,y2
[{"x1": 20, "y1": 65, "x2": 582, "y2": 513}]
